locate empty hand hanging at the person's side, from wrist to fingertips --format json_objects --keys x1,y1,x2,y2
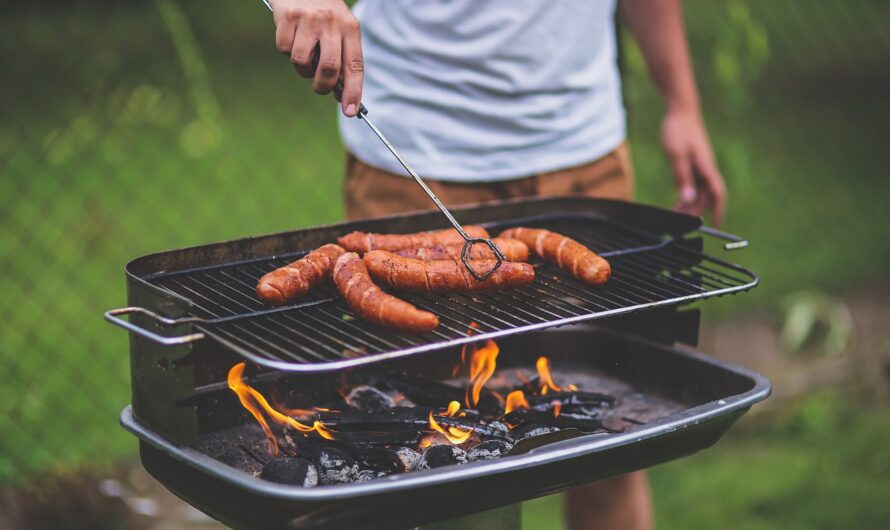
[{"x1": 661, "y1": 110, "x2": 726, "y2": 226}]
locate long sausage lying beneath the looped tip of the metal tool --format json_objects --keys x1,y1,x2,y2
[{"x1": 364, "y1": 250, "x2": 535, "y2": 293}]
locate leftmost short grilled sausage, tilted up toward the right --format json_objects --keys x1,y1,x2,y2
[{"x1": 256, "y1": 244, "x2": 345, "y2": 306}]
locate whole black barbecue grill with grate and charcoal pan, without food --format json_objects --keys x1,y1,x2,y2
[{"x1": 106, "y1": 198, "x2": 770, "y2": 528}]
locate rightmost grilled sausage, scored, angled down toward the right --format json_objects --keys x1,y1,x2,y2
[{"x1": 500, "y1": 227, "x2": 612, "y2": 285}]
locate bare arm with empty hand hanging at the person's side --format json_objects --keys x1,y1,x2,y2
[{"x1": 622, "y1": 0, "x2": 726, "y2": 225}]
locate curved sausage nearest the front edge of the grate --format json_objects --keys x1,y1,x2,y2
[{"x1": 333, "y1": 252, "x2": 439, "y2": 333}]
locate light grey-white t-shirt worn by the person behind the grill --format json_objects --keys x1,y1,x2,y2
[{"x1": 340, "y1": 0, "x2": 625, "y2": 182}]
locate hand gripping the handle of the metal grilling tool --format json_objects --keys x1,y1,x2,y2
[{"x1": 270, "y1": 0, "x2": 364, "y2": 117}]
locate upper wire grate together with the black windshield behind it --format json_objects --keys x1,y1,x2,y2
[{"x1": 110, "y1": 198, "x2": 758, "y2": 372}]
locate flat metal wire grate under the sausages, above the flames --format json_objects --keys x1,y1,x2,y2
[{"x1": 146, "y1": 215, "x2": 757, "y2": 371}]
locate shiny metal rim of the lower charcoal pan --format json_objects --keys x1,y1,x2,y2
[{"x1": 120, "y1": 330, "x2": 772, "y2": 502}]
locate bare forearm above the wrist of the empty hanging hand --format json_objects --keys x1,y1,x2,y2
[{"x1": 621, "y1": 0, "x2": 699, "y2": 113}]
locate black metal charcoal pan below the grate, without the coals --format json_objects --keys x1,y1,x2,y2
[{"x1": 121, "y1": 327, "x2": 770, "y2": 529}]
